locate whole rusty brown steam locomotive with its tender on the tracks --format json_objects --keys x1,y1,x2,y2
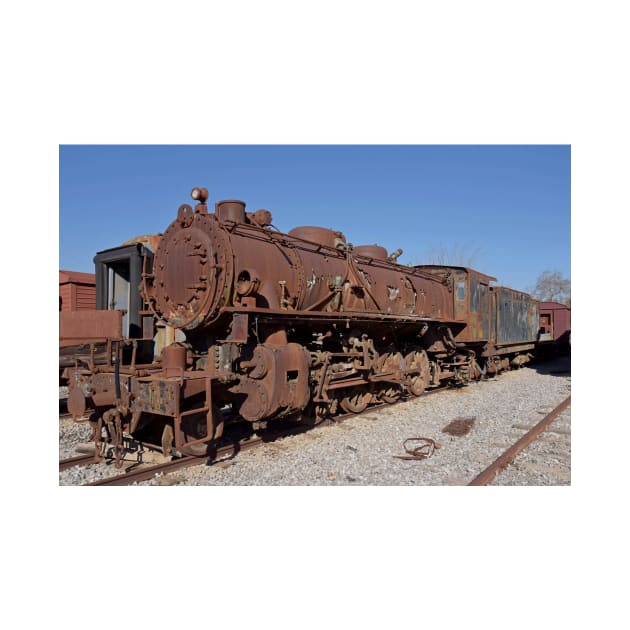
[{"x1": 63, "y1": 188, "x2": 539, "y2": 464}]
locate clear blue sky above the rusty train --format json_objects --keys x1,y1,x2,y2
[{"x1": 59, "y1": 145, "x2": 571, "y2": 290}]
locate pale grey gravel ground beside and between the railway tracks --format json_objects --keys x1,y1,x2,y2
[{"x1": 59, "y1": 359, "x2": 571, "y2": 486}]
